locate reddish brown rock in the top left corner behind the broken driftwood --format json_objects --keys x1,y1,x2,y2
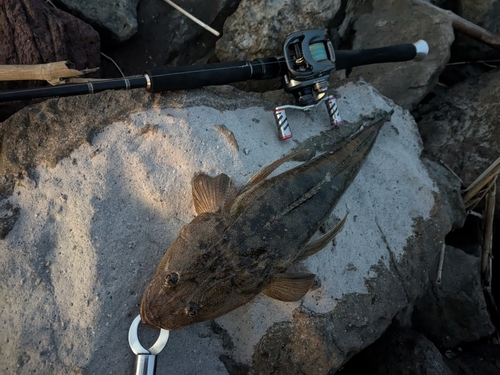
[{"x1": 0, "y1": 0, "x2": 100, "y2": 121}]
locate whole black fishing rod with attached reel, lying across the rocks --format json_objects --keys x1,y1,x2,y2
[{"x1": 0, "y1": 30, "x2": 429, "y2": 140}]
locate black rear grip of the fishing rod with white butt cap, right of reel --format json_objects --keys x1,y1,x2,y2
[{"x1": 335, "y1": 40, "x2": 429, "y2": 70}]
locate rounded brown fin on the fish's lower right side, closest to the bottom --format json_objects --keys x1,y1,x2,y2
[{"x1": 262, "y1": 273, "x2": 316, "y2": 302}]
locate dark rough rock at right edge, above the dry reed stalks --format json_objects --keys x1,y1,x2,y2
[{"x1": 417, "y1": 70, "x2": 500, "y2": 204}]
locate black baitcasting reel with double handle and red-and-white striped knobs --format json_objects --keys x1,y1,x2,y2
[{"x1": 274, "y1": 30, "x2": 342, "y2": 140}]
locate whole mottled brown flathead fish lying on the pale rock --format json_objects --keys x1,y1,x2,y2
[{"x1": 140, "y1": 119, "x2": 386, "y2": 330}]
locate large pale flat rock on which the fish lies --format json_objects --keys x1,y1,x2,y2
[{"x1": 0, "y1": 83, "x2": 463, "y2": 374}]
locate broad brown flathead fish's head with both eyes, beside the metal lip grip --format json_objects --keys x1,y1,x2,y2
[{"x1": 140, "y1": 213, "x2": 248, "y2": 330}]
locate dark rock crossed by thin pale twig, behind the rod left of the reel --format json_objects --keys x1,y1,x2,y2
[{"x1": 103, "y1": 0, "x2": 238, "y2": 76}]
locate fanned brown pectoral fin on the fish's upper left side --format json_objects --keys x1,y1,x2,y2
[{"x1": 191, "y1": 173, "x2": 237, "y2": 215}]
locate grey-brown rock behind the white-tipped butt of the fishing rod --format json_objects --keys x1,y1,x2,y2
[{"x1": 350, "y1": 0, "x2": 454, "y2": 108}]
